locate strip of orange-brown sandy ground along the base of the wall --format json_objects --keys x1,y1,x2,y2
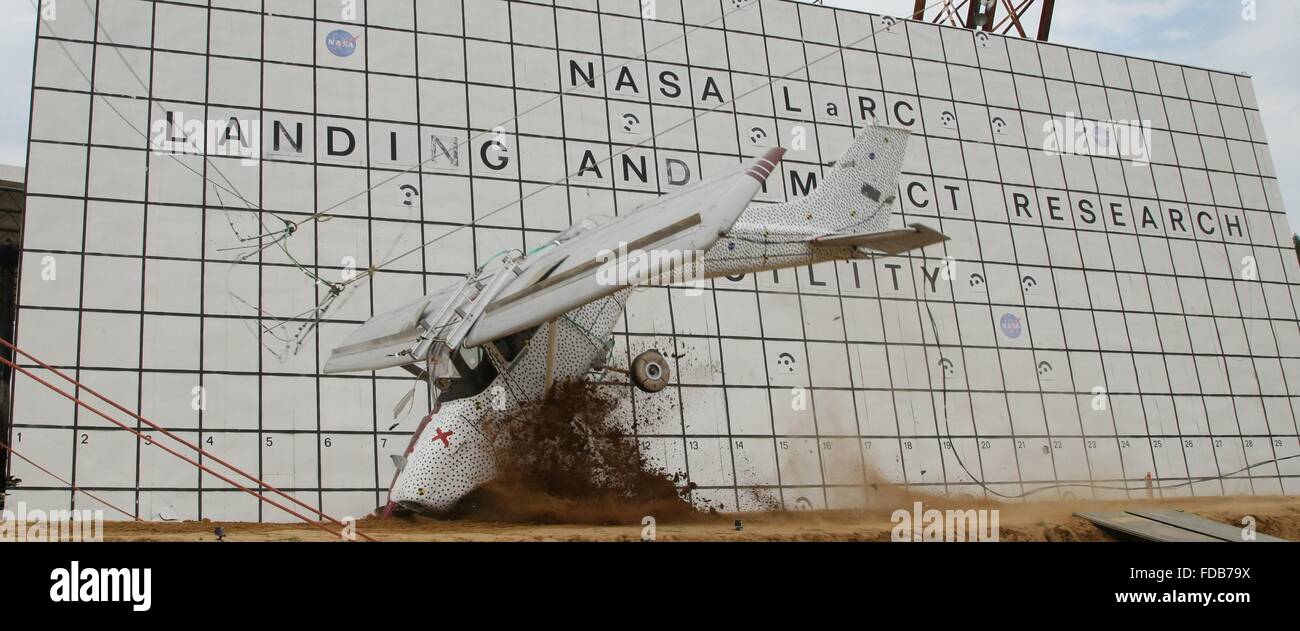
[{"x1": 104, "y1": 497, "x2": 1300, "y2": 541}]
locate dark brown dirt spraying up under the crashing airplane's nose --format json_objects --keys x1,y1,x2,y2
[{"x1": 451, "y1": 381, "x2": 701, "y2": 524}]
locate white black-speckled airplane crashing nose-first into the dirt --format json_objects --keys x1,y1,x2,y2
[{"x1": 324, "y1": 126, "x2": 948, "y2": 513}]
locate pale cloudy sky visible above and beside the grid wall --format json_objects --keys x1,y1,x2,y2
[{"x1": 0, "y1": 0, "x2": 1300, "y2": 232}]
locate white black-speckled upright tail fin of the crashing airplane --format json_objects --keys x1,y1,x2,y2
[{"x1": 745, "y1": 125, "x2": 911, "y2": 234}]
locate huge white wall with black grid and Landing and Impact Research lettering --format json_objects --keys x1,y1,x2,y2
[{"x1": 10, "y1": 0, "x2": 1300, "y2": 520}]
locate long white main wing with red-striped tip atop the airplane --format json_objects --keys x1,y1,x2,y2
[{"x1": 324, "y1": 148, "x2": 785, "y2": 373}]
